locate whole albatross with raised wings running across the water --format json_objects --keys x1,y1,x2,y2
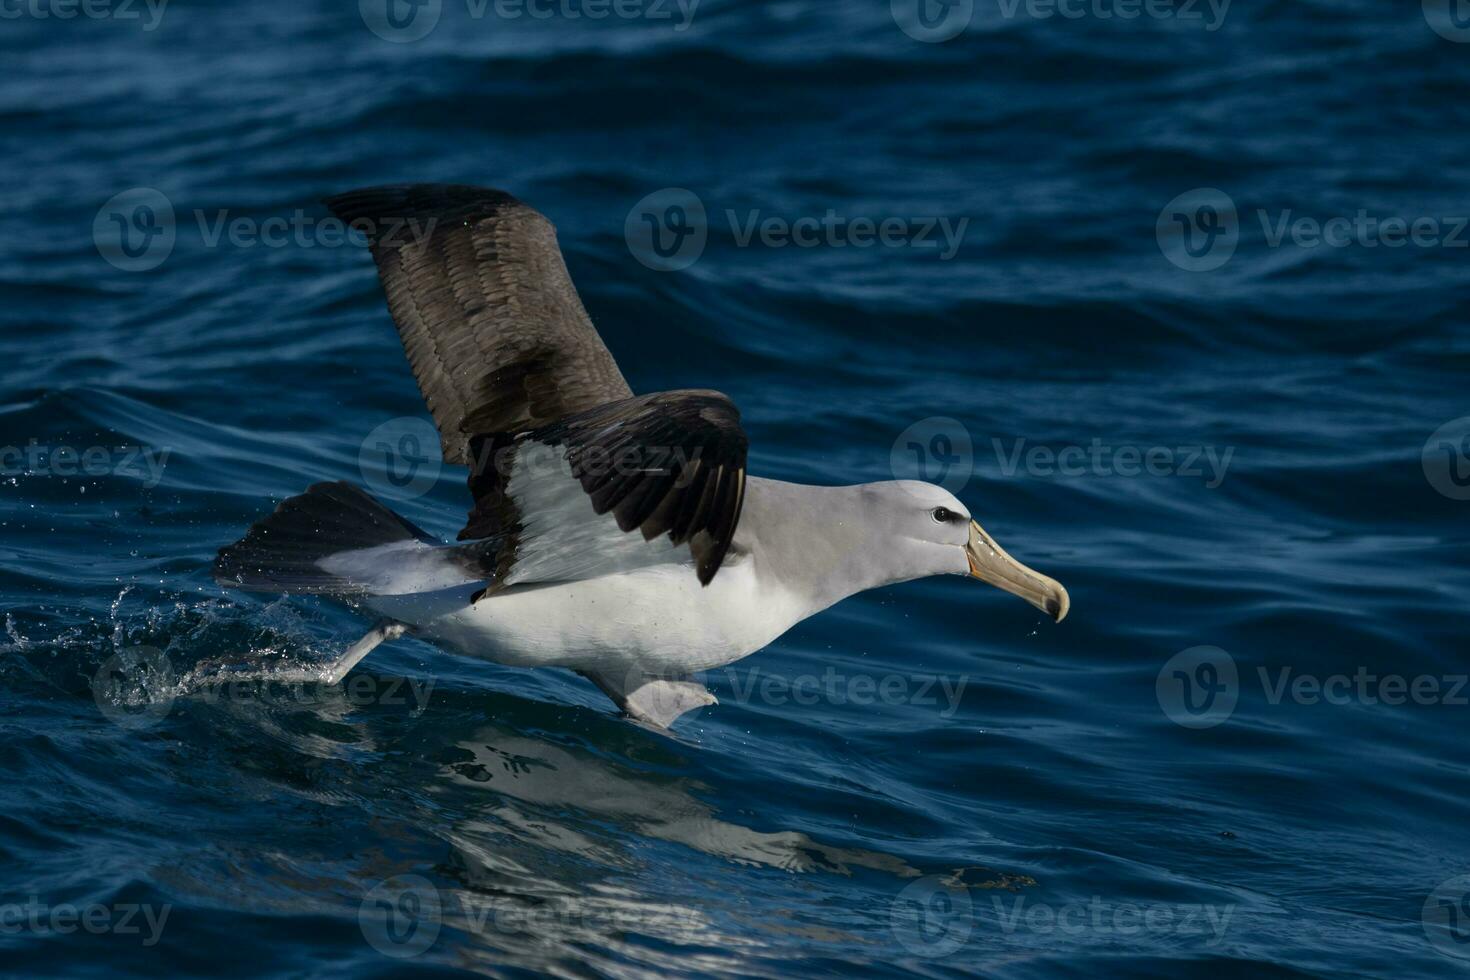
[{"x1": 213, "y1": 184, "x2": 1069, "y2": 729}]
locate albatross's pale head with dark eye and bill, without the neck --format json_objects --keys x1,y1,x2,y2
[{"x1": 861, "y1": 480, "x2": 1072, "y2": 623}]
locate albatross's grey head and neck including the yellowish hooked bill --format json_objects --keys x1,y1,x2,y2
[{"x1": 735, "y1": 478, "x2": 1072, "y2": 623}]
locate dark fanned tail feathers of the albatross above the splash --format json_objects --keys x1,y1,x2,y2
[{"x1": 215, "y1": 482, "x2": 438, "y2": 595}]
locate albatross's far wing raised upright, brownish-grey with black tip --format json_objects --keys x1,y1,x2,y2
[{"x1": 326, "y1": 184, "x2": 632, "y2": 466}]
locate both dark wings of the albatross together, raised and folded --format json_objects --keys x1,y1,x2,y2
[{"x1": 326, "y1": 184, "x2": 747, "y2": 591}]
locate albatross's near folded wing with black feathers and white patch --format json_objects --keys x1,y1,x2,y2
[{"x1": 460, "y1": 391, "x2": 747, "y2": 589}]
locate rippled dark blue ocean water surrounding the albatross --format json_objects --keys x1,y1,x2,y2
[{"x1": 0, "y1": 0, "x2": 1470, "y2": 977}]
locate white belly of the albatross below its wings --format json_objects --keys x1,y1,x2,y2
[{"x1": 366, "y1": 560, "x2": 807, "y2": 673}]
